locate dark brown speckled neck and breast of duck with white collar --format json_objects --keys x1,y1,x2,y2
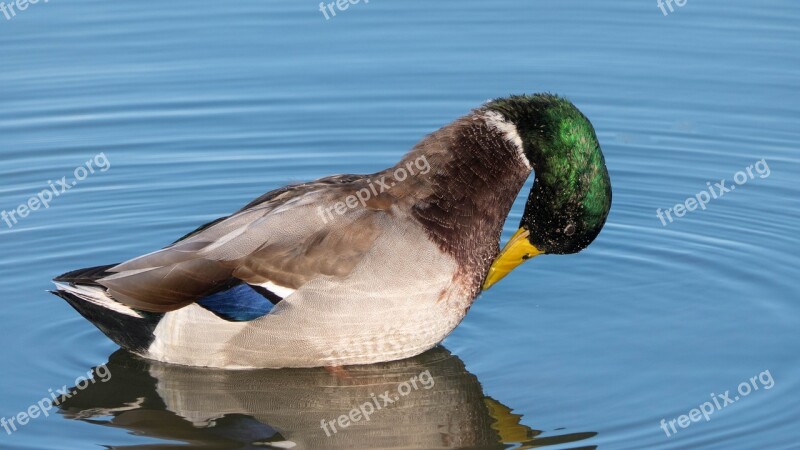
[{"x1": 392, "y1": 111, "x2": 531, "y2": 288}]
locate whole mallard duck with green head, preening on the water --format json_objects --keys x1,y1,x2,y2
[{"x1": 54, "y1": 94, "x2": 611, "y2": 368}]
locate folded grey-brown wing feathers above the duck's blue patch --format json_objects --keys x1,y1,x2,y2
[{"x1": 98, "y1": 175, "x2": 389, "y2": 312}]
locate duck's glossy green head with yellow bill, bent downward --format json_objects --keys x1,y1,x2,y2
[{"x1": 484, "y1": 94, "x2": 611, "y2": 289}]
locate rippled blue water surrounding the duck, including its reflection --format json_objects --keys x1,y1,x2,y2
[{"x1": 0, "y1": 0, "x2": 800, "y2": 449}]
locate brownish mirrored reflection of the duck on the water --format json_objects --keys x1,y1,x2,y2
[{"x1": 59, "y1": 347, "x2": 596, "y2": 450}]
